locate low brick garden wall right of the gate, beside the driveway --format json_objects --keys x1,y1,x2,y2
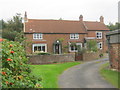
[{"x1": 83, "y1": 52, "x2": 100, "y2": 61}]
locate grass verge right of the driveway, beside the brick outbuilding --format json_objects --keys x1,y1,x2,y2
[{"x1": 100, "y1": 63, "x2": 120, "y2": 88}]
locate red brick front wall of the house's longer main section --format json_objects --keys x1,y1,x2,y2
[{"x1": 25, "y1": 34, "x2": 86, "y2": 53}]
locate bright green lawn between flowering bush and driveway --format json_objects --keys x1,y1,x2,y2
[{"x1": 30, "y1": 62, "x2": 80, "y2": 88}]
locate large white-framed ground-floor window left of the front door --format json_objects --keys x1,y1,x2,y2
[{"x1": 33, "y1": 44, "x2": 47, "y2": 52}]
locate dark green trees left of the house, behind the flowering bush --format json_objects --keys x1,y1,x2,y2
[{"x1": 0, "y1": 13, "x2": 23, "y2": 41}]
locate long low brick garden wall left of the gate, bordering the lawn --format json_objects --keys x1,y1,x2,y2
[{"x1": 28, "y1": 54, "x2": 75, "y2": 64}]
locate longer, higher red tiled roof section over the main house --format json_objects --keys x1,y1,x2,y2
[{"x1": 25, "y1": 19, "x2": 86, "y2": 33}]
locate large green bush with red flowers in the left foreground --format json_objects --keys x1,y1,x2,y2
[{"x1": 1, "y1": 40, "x2": 41, "y2": 88}]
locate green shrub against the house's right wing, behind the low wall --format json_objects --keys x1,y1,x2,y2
[{"x1": 87, "y1": 40, "x2": 98, "y2": 52}]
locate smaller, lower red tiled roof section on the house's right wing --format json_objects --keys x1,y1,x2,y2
[{"x1": 84, "y1": 21, "x2": 109, "y2": 30}]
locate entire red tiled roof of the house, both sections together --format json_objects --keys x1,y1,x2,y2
[{"x1": 25, "y1": 19, "x2": 109, "y2": 33}]
